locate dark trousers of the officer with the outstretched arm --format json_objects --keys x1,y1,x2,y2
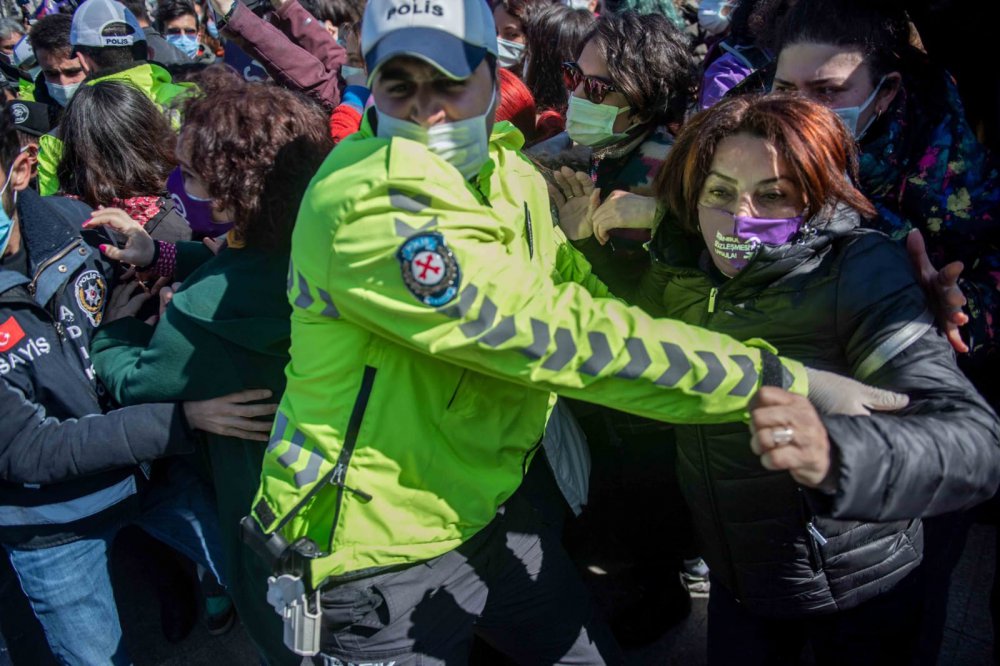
[{"x1": 321, "y1": 459, "x2": 624, "y2": 666}]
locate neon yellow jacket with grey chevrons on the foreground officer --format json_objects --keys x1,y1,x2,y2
[{"x1": 252, "y1": 118, "x2": 807, "y2": 584}]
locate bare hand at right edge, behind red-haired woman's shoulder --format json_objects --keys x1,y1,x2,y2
[{"x1": 906, "y1": 229, "x2": 969, "y2": 354}]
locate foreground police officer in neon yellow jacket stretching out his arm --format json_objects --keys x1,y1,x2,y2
[{"x1": 250, "y1": 0, "x2": 908, "y2": 663}]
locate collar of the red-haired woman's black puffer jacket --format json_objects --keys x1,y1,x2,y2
[{"x1": 649, "y1": 203, "x2": 861, "y2": 283}]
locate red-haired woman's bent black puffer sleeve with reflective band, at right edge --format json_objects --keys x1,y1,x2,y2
[{"x1": 823, "y1": 232, "x2": 1000, "y2": 522}]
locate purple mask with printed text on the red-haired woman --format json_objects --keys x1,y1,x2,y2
[{"x1": 698, "y1": 207, "x2": 802, "y2": 277}]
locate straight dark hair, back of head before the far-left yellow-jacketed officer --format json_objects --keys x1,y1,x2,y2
[{"x1": 56, "y1": 80, "x2": 177, "y2": 207}]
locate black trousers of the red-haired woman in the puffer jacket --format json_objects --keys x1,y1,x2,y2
[{"x1": 708, "y1": 569, "x2": 924, "y2": 666}]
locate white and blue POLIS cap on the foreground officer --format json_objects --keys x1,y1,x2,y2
[{"x1": 362, "y1": 0, "x2": 499, "y2": 79}]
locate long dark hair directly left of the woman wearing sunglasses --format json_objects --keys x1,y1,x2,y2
[{"x1": 524, "y1": 5, "x2": 595, "y2": 113}]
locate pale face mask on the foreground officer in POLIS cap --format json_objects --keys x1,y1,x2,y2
[{"x1": 375, "y1": 88, "x2": 497, "y2": 180}]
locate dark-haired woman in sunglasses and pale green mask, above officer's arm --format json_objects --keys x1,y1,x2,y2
[{"x1": 529, "y1": 11, "x2": 695, "y2": 272}]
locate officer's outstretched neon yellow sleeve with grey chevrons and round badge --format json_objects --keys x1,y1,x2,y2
[{"x1": 289, "y1": 169, "x2": 807, "y2": 423}]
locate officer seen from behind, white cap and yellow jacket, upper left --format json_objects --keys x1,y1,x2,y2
[{"x1": 38, "y1": 0, "x2": 197, "y2": 195}]
